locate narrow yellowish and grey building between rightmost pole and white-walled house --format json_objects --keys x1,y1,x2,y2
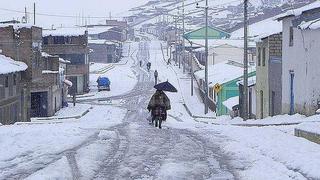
[{"x1": 256, "y1": 33, "x2": 282, "y2": 119}]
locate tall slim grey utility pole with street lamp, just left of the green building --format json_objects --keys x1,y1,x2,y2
[{"x1": 204, "y1": 0, "x2": 209, "y2": 114}]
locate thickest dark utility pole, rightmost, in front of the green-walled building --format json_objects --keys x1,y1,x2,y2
[{"x1": 242, "y1": 0, "x2": 248, "y2": 120}]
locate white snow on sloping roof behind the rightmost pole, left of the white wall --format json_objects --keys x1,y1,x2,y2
[{"x1": 231, "y1": 18, "x2": 282, "y2": 39}]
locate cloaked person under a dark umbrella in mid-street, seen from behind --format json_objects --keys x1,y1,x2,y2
[{"x1": 147, "y1": 81, "x2": 178, "y2": 129}]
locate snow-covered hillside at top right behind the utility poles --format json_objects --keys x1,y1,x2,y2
[{"x1": 125, "y1": 0, "x2": 315, "y2": 32}]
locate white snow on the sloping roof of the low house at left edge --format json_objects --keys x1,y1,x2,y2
[{"x1": 0, "y1": 54, "x2": 28, "y2": 74}]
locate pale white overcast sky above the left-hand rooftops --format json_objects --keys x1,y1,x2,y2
[{"x1": 0, "y1": 0, "x2": 148, "y2": 27}]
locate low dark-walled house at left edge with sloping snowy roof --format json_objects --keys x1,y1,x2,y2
[{"x1": 0, "y1": 55, "x2": 29, "y2": 125}]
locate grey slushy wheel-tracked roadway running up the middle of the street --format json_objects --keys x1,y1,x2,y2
[{"x1": 90, "y1": 42, "x2": 233, "y2": 179}]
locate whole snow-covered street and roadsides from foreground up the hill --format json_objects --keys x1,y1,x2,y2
[{"x1": 0, "y1": 40, "x2": 320, "y2": 180}]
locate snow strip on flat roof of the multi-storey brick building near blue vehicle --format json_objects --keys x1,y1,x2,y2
[{"x1": 42, "y1": 27, "x2": 86, "y2": 37}]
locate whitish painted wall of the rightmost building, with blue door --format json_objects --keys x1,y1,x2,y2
[{"x1": 282, "y1": 17, "x2": 320, "y2": 115}]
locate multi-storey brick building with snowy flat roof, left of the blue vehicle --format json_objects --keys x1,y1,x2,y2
[{"x1": 43, "y1": 28, "x2": 89, "y2": 94}]
